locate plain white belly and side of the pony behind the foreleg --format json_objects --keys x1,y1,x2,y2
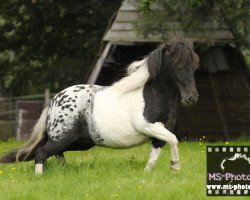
[{"x1": 92, "y1": 89, "x2": 148, "y2": 148}]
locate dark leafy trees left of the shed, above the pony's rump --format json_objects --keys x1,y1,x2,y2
[{"x1": 0, "y1": 0, "x2": 120, "y2": 95}]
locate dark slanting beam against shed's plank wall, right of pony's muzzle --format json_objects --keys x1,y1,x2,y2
[{"x1": 209, "y1": 73, "x2": 230, "y2": 140}]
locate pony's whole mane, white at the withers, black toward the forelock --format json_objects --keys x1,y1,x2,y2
[{"x1": 112, "y1": 41, "x2": 199, "y2": 93}]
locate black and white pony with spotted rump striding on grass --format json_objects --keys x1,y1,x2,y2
[{"x1": 0, "y1": 42, "x2": 199, "y2": 174}]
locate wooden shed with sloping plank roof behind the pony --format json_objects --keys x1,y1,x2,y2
[{"x1": 86, "y1": 0, "x2": 250, "y2": 140}]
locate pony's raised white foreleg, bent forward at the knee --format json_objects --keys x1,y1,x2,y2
[{"x1": 143, "y1": 122, "x2": 181, "y2": 170}]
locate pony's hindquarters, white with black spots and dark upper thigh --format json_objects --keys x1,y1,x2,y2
[{"x1": 47, "y1": 85, "x2": 101, "y2": 150}]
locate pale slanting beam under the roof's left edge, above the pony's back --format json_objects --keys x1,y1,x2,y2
[{"x1": 87, "y1": 42, "x2": 112, "y2": 84}]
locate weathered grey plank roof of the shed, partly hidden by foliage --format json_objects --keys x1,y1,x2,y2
[{"x1": 103, "y1": 0, "x2": 235, "y2": 43}]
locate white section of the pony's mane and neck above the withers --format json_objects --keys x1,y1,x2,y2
[{"x1": 111, "y1": 59, "x2": 149, "y2": 94}]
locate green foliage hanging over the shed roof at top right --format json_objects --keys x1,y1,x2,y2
[{"x1": 137, "y1": 0, "x2": 250, "y2": 48}]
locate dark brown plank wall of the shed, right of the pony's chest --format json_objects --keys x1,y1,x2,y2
[{"x1": 177, "y1": 70, "x2": 250, "y2": 141}]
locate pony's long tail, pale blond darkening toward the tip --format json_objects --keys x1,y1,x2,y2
[{"x1": 0, "y1": 106, "x2": 48, "y2": 163}]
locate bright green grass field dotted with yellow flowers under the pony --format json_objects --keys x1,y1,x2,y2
[{"x1": 0, "y1": 140, "x2": 250, "y2": 200}]
